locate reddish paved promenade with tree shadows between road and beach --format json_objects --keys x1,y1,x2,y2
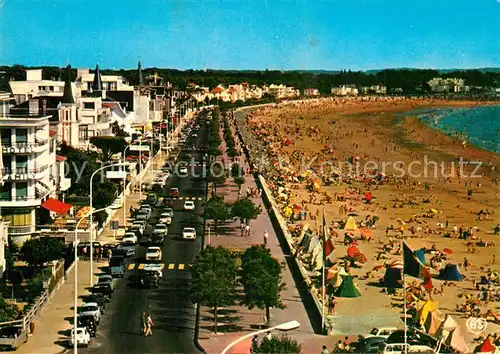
[{"x1": 199, "y1": 115, "x2": 338, "y2": 354}]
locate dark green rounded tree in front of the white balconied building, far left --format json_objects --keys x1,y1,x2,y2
[{"x1": 21, "y1": 237, "x2": 64, "y2": 268}]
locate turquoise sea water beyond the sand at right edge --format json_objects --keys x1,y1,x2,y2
[{"x1": 407, "y1": 106, "x2": 500, "y2": 154}]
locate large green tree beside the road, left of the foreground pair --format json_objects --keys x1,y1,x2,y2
[{"x1": 191, "y1": 246, "x2": 238, "y2": 333}]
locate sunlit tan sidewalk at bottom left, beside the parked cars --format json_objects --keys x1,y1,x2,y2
[{"x1": 16, "y1": 261, "x2": 107, "y2": 354}]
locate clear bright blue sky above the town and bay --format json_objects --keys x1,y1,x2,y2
[{"x1": 0, "y1": 0, "x2": 500, "y2": 70}]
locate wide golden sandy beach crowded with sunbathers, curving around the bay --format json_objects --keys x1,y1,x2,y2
[{"x1": 241, "y1": 98, "x2": 500, "y2": 348}]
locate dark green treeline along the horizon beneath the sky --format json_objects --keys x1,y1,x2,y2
[{"x1": 0, "y1": 65, "x2": 500, "y2": 94}]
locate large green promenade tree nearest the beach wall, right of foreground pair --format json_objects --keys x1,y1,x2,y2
[{"x1": 241, "y1": 245, "x2": 286, "y2": 326}]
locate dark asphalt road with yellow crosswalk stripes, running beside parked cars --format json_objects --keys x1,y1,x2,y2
[{"x1": 73, "y1": 115, "x2": 208, "y2": 354}]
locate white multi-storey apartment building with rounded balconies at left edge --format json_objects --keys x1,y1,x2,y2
[{"x1": 0, "y1": 99, "x2": 71, "y2": 244}]
